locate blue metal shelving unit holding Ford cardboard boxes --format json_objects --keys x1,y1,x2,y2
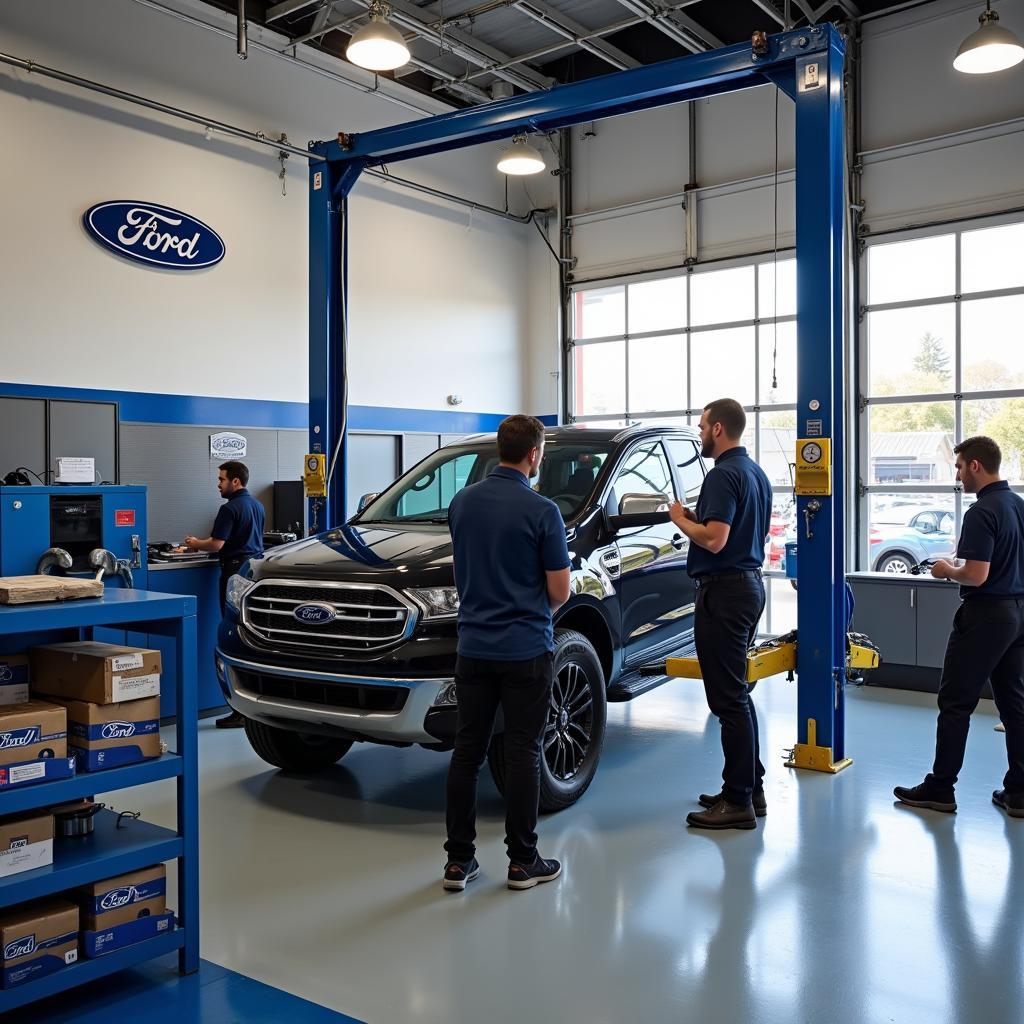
[{"x1": 0, "y1": 590, "x2": 199, "y2": 1016}]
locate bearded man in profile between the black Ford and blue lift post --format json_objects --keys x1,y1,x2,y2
[{"x1": 669, "y1": 398, "x2": 771, "y2": 828}]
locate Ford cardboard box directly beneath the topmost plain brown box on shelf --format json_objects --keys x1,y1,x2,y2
[{"x1": 54, "y1": 697, "x2": 160, "y2": 771}]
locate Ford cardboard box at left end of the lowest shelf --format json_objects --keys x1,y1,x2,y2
[{"x1": 0, "y1": 899, "x2": 78, "y2": 988}]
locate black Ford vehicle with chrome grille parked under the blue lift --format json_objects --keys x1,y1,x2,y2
[{"x1": 217, "y1": 427, "x2": 705, "y2": 811}]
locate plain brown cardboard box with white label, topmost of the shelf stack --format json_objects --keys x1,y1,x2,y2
[{"x1": 29, "y1": 641, "x2": 161, "y2": 703}]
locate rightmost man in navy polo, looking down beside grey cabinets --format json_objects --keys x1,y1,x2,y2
[{"x1": 893, "y1": 436, "x2": 1024, "y2": 818}]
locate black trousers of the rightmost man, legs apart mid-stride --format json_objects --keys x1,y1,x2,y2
[{"x1": 928, "y1": 598, "x2": 1024, "y2": 795}]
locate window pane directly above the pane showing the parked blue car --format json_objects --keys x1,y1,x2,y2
[{"x1": 868, "y1": 401, "x2": 956, "y2": 483}]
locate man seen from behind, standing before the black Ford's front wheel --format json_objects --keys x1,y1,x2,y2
[{"x1": 442, "y1": 416, "x2": 569, "y2": 892}]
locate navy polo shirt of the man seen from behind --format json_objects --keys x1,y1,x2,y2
[{"x1": 449, "y1": 466, "x2": 569, "y2": 662}]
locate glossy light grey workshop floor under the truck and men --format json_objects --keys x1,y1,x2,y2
[{"x1": 123, "y1": 678, "x2": 1024, "y2": 1024}]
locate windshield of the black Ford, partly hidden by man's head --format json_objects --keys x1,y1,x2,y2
[{"x1": 356, "y1": 441, "x2": 608, "y2": 522}]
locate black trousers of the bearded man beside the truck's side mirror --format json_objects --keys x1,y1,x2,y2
[{"x1": 693, "y1": 572, "x2": 765, "y2": 807}]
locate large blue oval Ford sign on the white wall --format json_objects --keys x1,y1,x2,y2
[{"x1": 82, "y1": 200, "x2": 224, "y2": 270}]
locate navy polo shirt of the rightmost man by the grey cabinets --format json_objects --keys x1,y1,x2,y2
[{"x1": 956, "y1": 480, "x2": 1024, "y2": 599}]
